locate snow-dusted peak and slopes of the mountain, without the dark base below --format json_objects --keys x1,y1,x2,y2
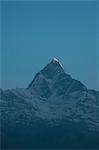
[{"x1": 0, "y1": 58, "x2": 99, "y2": 148}]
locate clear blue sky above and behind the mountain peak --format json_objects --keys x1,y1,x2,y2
[{"x1": 1, "y1": 1, "x2": 99, "y2": 89}]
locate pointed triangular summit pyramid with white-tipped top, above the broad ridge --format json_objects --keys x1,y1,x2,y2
[{"x1": 28, "y1": 58, "x2": 86, "y2": 98}]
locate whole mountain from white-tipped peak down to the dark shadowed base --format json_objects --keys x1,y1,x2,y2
[{"x1": 0, "y1": 58, "x2": 99, "y2": 149}]
